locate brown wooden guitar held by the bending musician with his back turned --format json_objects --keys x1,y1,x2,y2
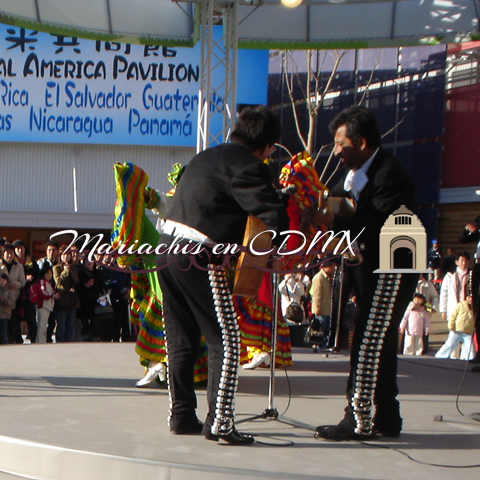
[{"x1": 232, "y1": 215, "x2": 272, "y2": 298}]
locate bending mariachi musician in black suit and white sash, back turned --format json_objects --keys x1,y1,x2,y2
[{"x1": 157, "y1": 107, "x2": 288, "y2": 445}]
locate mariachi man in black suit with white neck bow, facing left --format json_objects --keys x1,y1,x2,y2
[{"x1": 315, "y1": 106, "x2": 418, "y2": 441}]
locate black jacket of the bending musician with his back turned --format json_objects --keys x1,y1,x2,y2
[{"x1": 167, "y1": 143, "x2": 288, "y2": 245}]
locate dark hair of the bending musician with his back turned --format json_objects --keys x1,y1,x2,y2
[{"x1": 231, "y1": 105, "x2": 281, "y2": 152}]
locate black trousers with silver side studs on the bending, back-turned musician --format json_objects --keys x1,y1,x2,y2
[{"x1": 157, "y1": 235, "x2": 240, "y2": 434}]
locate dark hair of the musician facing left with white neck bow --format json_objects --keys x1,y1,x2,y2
[{"x1": 329, "y1": 105, "x2": 382, "y2": 147}]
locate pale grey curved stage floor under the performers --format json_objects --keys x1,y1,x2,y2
[{"x1": 0, "y1": 343, "x2": 480, "y2": 480}]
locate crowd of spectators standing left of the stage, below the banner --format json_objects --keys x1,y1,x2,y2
[{"x1": 0, "y1": 237, "x2": 134, "y2": 344}]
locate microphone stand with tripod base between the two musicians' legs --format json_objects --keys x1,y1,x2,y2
[{"x1": 236, "y1": 273, "x2": 315, "y2": 432}]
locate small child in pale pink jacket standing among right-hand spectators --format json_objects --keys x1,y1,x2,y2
[{"x1": 399, "y1": 293, "x2": 430, "y2": 355}]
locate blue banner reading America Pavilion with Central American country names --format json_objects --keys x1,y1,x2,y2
[{"x1": 0, "y1": 24, "x2": 268, "y2": 146}]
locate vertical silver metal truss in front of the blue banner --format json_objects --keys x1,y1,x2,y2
[{"x1": 197, "y1": 0, "x2": 239, "y2": 152}]
